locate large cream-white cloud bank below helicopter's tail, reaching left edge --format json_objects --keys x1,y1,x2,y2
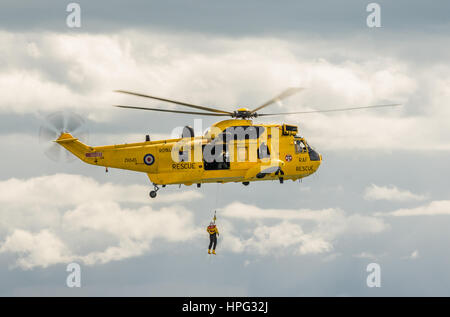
[{"x1": 0, "y1": 174, "x2": 202, "y2": 269}]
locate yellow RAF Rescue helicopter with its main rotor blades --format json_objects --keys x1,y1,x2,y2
[{"x1": 49, "y1": 87, "x2": 397, "y2": 198}]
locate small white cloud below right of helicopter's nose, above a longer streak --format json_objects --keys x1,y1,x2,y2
[{"x1": 364, "y1": 184, "x2": 427, "y2": 202}]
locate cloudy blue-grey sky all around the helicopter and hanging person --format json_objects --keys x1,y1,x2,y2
[{"x1": 0, "y1": 0, "x2": 450, "y2": 296}]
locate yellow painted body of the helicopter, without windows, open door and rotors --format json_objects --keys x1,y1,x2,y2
[{"x1": 55, "y1": 119, "x2": 322, "y2": 185}]
